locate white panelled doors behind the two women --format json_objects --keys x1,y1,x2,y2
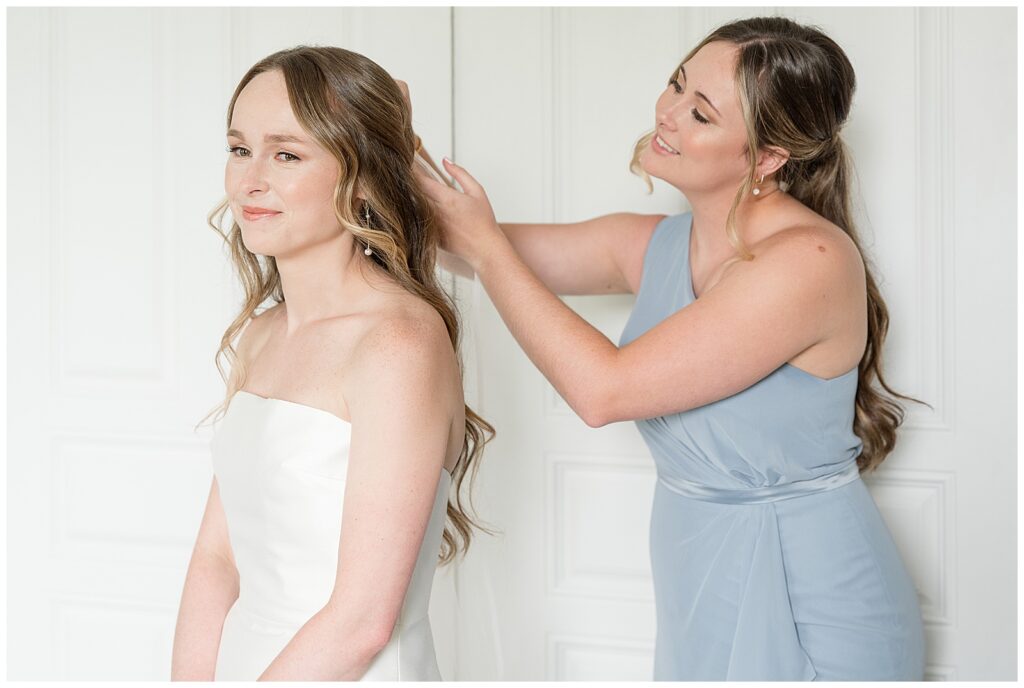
[{"x1": 7, "y1": 7, "x2": 1017, "y2": 680}]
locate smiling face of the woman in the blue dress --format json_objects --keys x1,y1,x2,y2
[{"x1": 640, "y1": 41, "x2": 749, "y2": 194}]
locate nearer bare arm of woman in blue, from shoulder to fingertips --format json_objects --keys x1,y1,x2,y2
[{"x1": 425, "y1": 161, "x2": 864, "y2": 427}]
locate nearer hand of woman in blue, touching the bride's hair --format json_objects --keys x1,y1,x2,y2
[{"x1": 417, "y1": 158, "x2": 508, "y2": 272}]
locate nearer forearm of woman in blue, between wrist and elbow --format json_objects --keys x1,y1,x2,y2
[{"x1": 476, "y1": 232, "x2": 618, "y2": 427}]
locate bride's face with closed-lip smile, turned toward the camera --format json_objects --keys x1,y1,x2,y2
[{"x1": 224, "y1": 70, "x2": 342, "y2": 257}]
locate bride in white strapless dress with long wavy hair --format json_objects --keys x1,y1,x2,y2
[{"x1": 171, "y1": 46, "x2": 493, "y2": 681}]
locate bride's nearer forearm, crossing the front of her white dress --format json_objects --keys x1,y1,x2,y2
[{"x1": 258, "y1": 605, "x2": 390, "y2": 681}]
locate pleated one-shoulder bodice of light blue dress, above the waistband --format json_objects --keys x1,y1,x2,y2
[{"x1": 620, "y1": 213, "x2": 861, "y2": 489}]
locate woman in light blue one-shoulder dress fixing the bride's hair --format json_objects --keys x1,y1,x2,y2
[{"x1": 422, "y1": 17, "x2": 924, "y2": 680}]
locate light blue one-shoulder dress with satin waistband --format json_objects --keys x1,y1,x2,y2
[{"x1": 620, "y1": 213, "x2": 925, "y2": 681}]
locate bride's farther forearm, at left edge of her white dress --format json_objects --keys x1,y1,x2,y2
[{"x1": 171, "y1": 555, "x2": 239, "y2": 681}]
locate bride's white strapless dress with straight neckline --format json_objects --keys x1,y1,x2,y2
[{"x1": 210, "y1": 391, "x2": 452, "y2": 681}]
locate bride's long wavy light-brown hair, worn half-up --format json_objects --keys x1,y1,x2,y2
[{"x1": 200, "y1": 45, "x2": 495, "y2": 564}]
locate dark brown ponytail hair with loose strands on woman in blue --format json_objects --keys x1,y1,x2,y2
[{"x1": 630, "y1": 16, "x2": 928, "y2": 473}]
